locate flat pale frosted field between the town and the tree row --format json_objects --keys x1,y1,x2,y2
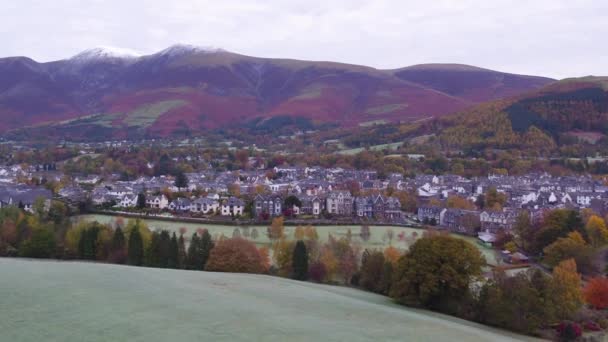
[{"x1": 76, "y1": 215, "x2": 497, "y2": 265}]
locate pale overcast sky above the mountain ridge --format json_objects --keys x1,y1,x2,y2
[{"x1": 0, "y1": 0, "x2": 608, "y2": 78}]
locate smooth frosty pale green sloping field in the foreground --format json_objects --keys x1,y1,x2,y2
[{"x1": 0, "y1": 258, "x2": 527, "y2": 342}]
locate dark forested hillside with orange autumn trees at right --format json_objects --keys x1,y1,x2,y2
[{"x1": 342, "y1": 77, "x2": 608, "y2": 155}]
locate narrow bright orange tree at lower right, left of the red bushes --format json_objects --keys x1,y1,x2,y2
[{"x1": 550, "y1": 259, "x2": 583, "y2": 319}]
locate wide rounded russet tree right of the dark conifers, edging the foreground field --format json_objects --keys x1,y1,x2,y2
[{"x1": 205, "y1": 238, "x2": 265, "y2": 273}]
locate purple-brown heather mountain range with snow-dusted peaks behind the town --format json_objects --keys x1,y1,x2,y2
[{"x1": 0, "y1": 45, "x2": 553, "y2": 139}]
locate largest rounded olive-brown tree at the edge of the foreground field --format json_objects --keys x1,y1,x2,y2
[{"x1": 390, "y1": 235, "x2": 485, "y2": 308}]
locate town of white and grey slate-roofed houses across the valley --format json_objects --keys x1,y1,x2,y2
[{"x1": 0, "y1": 159, "x2": 608, "y2": 244}]
